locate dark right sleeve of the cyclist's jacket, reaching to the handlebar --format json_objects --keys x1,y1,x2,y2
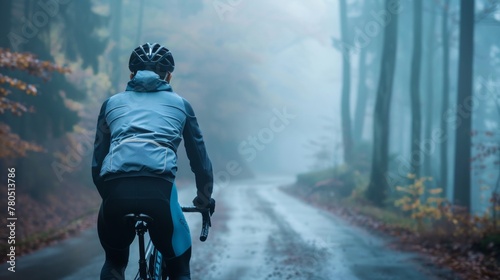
[{"x1": 183, "y1": 100, "x2": 214, "y2": 203}]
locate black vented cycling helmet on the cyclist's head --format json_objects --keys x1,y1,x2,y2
[{"x1": 128, "y1": 43, "x2": 175, "y2": 78}]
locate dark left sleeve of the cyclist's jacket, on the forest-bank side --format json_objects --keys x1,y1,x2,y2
[{"x1": 92, "y1": 100, "x2": 111, "y2": 190}]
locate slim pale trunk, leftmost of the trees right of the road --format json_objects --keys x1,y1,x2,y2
[{"x1": 340, "y1": 0, "x2": 352, "y2": 163}]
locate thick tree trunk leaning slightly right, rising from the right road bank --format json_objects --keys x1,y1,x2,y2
[{"x1": 366, "y1": 0, "x2": 398, "y2": 206}]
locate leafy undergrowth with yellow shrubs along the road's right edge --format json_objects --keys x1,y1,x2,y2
[{"x1": 287, "y1": 162, "x2": 500, "y2": 279}]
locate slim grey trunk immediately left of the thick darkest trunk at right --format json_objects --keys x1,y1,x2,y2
[{"x1": 439, "y1": 0, "x2": 450, "y2": 197}]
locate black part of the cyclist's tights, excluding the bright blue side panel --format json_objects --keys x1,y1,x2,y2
[{"x1": 97, "y1": 177, "x2": 191, "y2": 280}]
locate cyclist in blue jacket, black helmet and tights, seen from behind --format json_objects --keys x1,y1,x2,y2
[{"x1": 92, "y1": 43, "x2": 213, "y2": 280}]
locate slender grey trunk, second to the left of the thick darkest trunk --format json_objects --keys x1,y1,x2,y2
[{"x1": 423, "y1": 5, "x2": 436, "y2": 176}]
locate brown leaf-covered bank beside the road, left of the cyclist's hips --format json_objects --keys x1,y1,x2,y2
[{"x1": 0, "y1": 180, "x2": 101, "y2": 261}]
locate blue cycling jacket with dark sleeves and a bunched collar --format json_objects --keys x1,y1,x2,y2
[{"x1": 92, "y1": 71, "x2": 213, "y2": 198}]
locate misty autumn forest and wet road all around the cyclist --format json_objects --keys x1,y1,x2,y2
[{"x1": 0, "y1": 0, "x2": 500, "y2": 280}]
